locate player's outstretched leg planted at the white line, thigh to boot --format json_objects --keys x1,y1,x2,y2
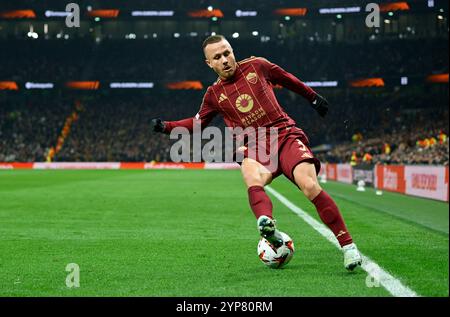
[{"x1": 293, "y1": 161, "x2": 362, "y2": 270}]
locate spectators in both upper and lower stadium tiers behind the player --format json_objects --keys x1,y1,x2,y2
[{"x1": 0, "y1": 38, "x2": 449, "y2": 164}]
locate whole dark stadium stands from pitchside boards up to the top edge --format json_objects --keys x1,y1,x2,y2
[{"x1": 0, "y1": 0, "x2": 448, "y2": 164}]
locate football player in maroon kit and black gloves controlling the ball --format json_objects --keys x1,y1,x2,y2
[{"x1": 151, "y1": 35, "x2": 362, "y2": 270}]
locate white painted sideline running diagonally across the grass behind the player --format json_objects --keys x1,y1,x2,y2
[{"x1": 265, "y1": 186, "x2": 419, "y2": 297}]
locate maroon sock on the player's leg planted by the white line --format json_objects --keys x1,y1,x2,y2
[{"x1": 312, "y1": 190, "x2": 353, "y2": 247}]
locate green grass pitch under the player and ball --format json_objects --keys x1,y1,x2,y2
[{"x1": 0, "y1": 170, "x2": 449, "y2": 297}]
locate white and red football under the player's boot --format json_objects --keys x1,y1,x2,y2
[{"x1": 258, "y1": 232, "x2": 295, "y2": 269}]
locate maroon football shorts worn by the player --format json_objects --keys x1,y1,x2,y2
[{"x1": 239, "y1": 127, "x2": 320, "y2": 183}]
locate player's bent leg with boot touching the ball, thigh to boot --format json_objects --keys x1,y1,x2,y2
[{"x1": 241, "y1": 158, "x2": 283, "y2": 247}]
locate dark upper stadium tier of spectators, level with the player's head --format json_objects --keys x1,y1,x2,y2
[{"x1": 0, "y1": 37, "x2": 448, "y2": 83}]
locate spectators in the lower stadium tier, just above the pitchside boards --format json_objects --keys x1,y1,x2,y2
[{"x1": 0, "y1": 85, "x2": 449, "y2": 164}]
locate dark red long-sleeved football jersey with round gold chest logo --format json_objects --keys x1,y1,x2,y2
[{"x1": 165, "y1": 57, "x2": 316, "y2": 133}]
